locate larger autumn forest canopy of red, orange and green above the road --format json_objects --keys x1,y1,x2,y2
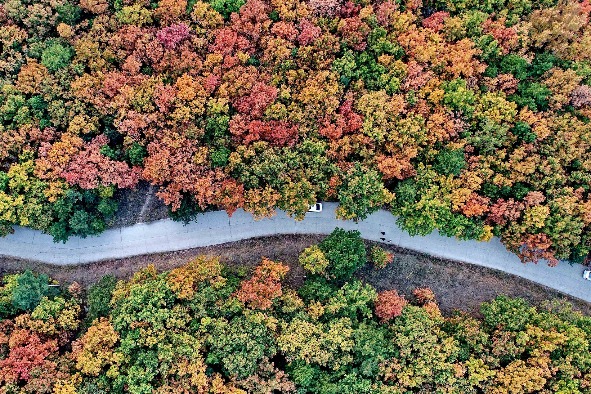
[{"x1": 0, "y1": 0, "x2": 591, "y2": 261}]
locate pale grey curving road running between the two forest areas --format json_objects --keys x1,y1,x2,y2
[{"x1": 0, "y1": 203, "x2": 591, "y2": 302}]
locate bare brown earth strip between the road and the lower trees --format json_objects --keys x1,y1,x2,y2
[{"x1": 0, "y1": 235, "x2": 591, "y2": 315}]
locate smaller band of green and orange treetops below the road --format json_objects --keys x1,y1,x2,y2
[{"x1": 0, "y1": 230, "x2": 591, "y2": 394}]
